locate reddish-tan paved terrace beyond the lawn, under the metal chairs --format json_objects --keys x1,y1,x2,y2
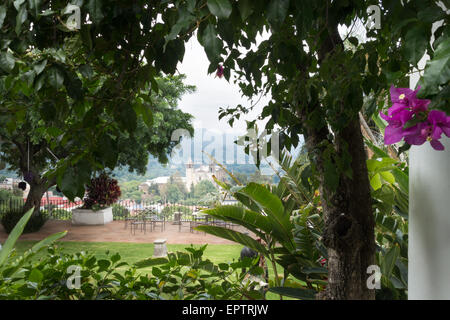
[{"x1": 0, "y1": 220, "x2": 251, "y2": 244}]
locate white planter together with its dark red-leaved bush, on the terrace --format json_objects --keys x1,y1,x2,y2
[{"x1": 72, "y1": 173, "x2": 121, "y2": 225}]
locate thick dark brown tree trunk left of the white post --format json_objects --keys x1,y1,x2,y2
[{"x1": 305, "y1": 119, "x2": 375, "y2": 300}]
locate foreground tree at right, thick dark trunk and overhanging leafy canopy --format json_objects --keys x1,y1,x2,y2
[{"x1": 160, "y1": 0, "x2": 450, "y2": 299}]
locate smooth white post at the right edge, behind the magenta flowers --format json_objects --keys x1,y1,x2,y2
[{"x1": 408, "y1": 10, "x2": 450, "y2": 300}]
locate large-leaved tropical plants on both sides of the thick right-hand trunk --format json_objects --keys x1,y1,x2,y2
[{"x1": 197, "y1": 149, "x2": 409, "y2": 300}]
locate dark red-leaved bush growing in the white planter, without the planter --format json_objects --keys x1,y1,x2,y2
[{"x1": 83, "y1": 173, "x2": 121, "y2": 210}]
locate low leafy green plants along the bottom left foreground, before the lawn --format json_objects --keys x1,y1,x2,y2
[{"x1": 0, "y1": 210, "x2": 265, "y2": 300}]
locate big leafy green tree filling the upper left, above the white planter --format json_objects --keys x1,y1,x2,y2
[{"x1": 0, "y1": 0, "x2": 197, "y2": 215}]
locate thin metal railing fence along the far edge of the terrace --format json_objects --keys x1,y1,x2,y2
[{"x1": 0, "y1": 198, "x2": 213, "y2": 221}]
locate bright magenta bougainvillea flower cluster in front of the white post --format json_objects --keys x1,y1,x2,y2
[{"x1": 380, "y1": 86, "x2": 450, "y2": 150}]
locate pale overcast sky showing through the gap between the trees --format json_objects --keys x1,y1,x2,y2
[{"x1": 172, "y1": 22, "x2": 365, "y2": 168}]
